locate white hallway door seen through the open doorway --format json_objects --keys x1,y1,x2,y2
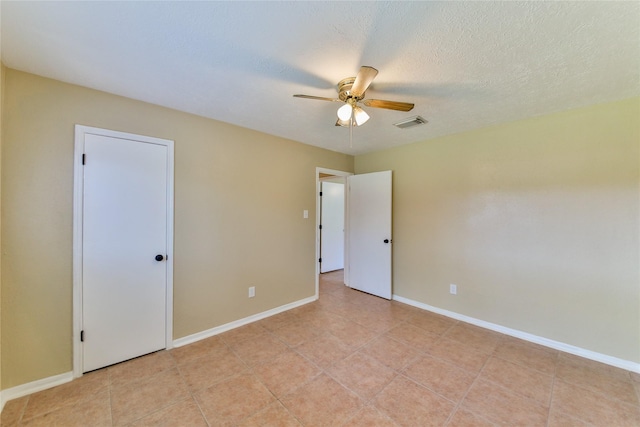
[{"x1": 320, "y1": 178, "x2": 344, "y2": 273}]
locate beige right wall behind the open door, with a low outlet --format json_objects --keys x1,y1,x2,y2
[{"x1": 355, "y1": 98, "x2": 640, "y2": 363}]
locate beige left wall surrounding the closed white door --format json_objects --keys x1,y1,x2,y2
[{"x1": 1, "y1": 69, "x2": 353, "y2": 389}]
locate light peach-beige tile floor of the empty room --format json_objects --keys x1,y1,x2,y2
[{"x1": 2, "y1": 271, "x2": 640, "y2": 427}]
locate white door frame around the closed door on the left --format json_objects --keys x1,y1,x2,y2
[{"x1": 72, "y1": 124, "x2": 174, "y2": 378}]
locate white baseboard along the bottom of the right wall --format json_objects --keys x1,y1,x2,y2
[{"x1": 393, "y1": 295, "x2": 640, "y2": 373}]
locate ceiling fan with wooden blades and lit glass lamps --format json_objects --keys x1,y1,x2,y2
[{"x1": 293, "y1": 65, "x2": 413, "y2": 127}]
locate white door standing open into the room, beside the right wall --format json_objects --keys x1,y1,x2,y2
[{"x1": 347, "y1": 171, "x2": 391, "y2": 299}]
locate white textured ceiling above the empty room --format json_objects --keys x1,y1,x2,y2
[{"x1": 1, "y1": 1, "x2": 640, "y2": 154}]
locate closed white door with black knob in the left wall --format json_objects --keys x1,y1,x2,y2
[{"x1": 75, "y1": 125, "x2": 173, "y2": 372}]
